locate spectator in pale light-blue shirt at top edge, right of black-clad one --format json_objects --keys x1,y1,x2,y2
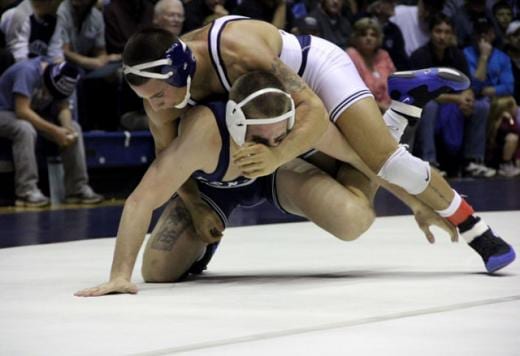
[{"x1": 390, "y1": 0, "x2": 444, "y2": 56}]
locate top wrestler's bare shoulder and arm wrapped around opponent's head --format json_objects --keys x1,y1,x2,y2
[{"x1": 220, "y1": 21, "x2": 329, "y2": 177}]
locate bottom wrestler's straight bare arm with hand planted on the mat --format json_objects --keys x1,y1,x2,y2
[{"x1": 75, "y1": 107, "x2": 221, "y2": 297}]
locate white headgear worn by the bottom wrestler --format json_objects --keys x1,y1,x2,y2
[{"x1": 226, "y1": 88, "x2": 295, "y2": 146}]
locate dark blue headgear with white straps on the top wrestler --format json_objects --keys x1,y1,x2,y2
[{"x1": 123, "y1": 39, "x2": 196, "y2": 109}]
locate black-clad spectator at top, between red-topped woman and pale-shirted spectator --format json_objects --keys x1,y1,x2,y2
[{"x1": 367, "y1": 0, "x2": 410, "y2": 70}]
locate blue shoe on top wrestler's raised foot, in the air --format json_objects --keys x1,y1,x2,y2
[{"x1": 388, "y1": 68, "x2": 470, "y2": 108}]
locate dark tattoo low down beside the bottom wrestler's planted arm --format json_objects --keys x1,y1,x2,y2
[{"x1": 152, "y1": 206, "x2": 193, "y2": 251}]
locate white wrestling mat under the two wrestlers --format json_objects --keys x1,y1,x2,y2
[{"x1": 0, "y1": 211, "x2": 520, "y2": 356}]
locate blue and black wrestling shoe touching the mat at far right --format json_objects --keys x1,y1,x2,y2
[{"x1": 469, "y1": 229, "x2": 516, "y2": 273}]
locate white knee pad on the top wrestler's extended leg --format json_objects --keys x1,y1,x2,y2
[{"x1": 377, "y1": 146, "x2": 431, "y2": 195}]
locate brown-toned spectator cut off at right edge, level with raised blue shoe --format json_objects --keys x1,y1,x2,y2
[{"x1": 487, "y1": 96, "x2": 520, "y2": 177}]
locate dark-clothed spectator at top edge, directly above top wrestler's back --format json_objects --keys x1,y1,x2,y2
[{"x1": 233, "y1": 0, "x2": 287, "y2": 29}]
